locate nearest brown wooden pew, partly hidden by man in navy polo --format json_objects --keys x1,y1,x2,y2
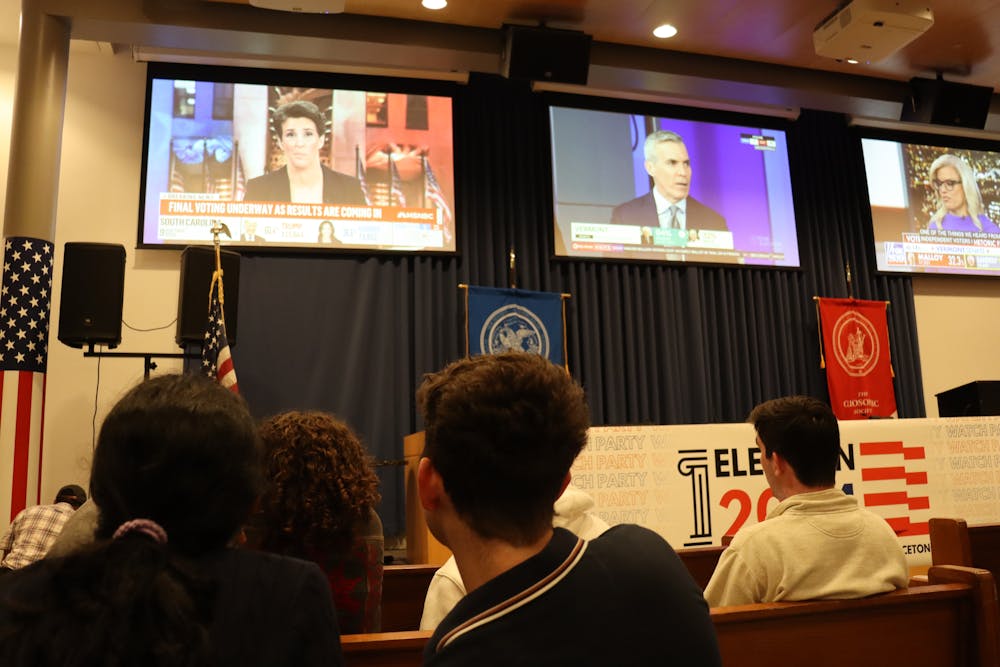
[{"x1": 341, "y1": 566, "x2": 1000, "y2": 667}]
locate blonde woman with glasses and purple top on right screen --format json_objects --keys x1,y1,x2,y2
[{"x1": 927, "y1": 153, "x2": 1000, "y2": 234}]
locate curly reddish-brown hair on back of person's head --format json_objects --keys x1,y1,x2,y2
[{"x1": 255, "y1": 411, "x2": 380, "y2": 557}]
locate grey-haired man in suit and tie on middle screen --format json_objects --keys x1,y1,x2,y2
[{"x1": 611, "y1": 130, "x2": 729, "y2": 231}]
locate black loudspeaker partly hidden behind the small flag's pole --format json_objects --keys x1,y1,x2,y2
[{"x1": 175, "y1": 246, "x2": 240, "y2": 347}]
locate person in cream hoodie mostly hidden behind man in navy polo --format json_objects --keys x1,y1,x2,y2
[{"x1": 420, "y1": 483, "x2": 608, "y2": 630}]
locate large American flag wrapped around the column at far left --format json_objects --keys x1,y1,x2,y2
[{"x1": 0, "y1": 236, "x2": 53, "y2": 521}]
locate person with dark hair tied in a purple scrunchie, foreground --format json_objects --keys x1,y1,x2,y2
[{"x1": 0, "y1": 374, "x2": 342, "y2": 667}]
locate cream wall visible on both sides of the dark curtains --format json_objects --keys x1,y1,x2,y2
[{"x1": 0, "y1": 39, "x2": 1000, "y2": 516}]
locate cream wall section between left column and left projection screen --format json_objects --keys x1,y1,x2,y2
[{"x1": 36, "y1": 47, "x2": 181, "y2": 502}]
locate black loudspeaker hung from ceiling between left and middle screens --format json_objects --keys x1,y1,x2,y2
[{"x1": 503, "y1": 25, "x2": 592, "y2": 85}]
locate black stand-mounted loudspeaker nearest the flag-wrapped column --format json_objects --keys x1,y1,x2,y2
[{"x1": 58, "y1": 243, "x2": 125, "y2": 348}]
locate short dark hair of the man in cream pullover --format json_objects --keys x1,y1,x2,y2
[{"x1": 747, "y1": 396, "x2": 840, "y2": 487}]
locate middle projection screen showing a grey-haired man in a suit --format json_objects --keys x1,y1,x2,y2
[{"x1": 549, "y1": 106, "x2": 799, "y2": 267}]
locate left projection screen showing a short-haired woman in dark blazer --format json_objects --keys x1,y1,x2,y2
[{"x1": 138, "y1": 64, "x2": 457, "y2": 253}]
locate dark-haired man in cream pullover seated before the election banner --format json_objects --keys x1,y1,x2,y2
[{"x1": 705, "y1": 396, "x2": 909, "y2": 607}]
